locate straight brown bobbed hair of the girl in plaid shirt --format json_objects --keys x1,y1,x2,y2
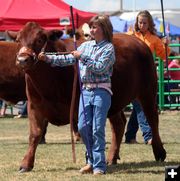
[{"x1": 89, "y1": 15, "x2": 113, "y2": 42}]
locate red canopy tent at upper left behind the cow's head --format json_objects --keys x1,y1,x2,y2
[{"x1": 0, "y1": 0, "x2": 95, "y2": 31}]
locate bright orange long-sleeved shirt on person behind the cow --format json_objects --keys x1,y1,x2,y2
[{"x1": 127, "y1": 31, "x2": 170, "y2": 60}]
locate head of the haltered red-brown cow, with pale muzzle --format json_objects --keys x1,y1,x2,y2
[{"x1": 10, "y1": 22, "x2": 66, "y2": 69}]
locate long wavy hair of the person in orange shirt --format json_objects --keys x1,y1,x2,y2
[{"x1": 134, "y1": 10, "x2": 157, "y2": 35}]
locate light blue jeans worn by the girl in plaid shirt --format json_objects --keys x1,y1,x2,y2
[{"x1": 78, "y1": 88, "x2": 111, "y2": 173}]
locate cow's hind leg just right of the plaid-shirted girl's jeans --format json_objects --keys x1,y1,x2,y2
[{"x1": 107, "y1": 111, "x2": 126, "y2": 165}]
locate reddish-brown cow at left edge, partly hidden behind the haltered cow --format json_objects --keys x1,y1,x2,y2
[{"x1": 0, "y1": 41, "x2": 27, "y2": 104}]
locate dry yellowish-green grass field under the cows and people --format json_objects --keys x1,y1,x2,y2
[{"x1": 0, "y1": 111, "x2": 180, "y2": 181}]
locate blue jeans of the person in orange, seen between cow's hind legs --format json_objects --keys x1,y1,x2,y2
[{"x1": 125, "y1": 101, "x2": 152, "y2": 143}]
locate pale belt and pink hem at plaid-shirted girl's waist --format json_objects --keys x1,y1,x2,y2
[{"x1": 82, "y1": 83, "x2": 113, "y2": 95}]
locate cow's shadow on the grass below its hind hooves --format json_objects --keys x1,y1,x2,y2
[{"x1": 107, "y1": 161, "x2": 180, "y2": 174}]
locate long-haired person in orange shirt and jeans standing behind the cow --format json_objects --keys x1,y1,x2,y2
[{"x1": 125, "y1": 10, "x2": 170, "y2": 144}]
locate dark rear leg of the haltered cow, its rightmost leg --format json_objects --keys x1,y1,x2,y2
[{"x1": 140, "y1": 96, "x2": 166, "y2": 161}]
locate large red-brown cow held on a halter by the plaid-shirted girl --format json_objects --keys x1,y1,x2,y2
[{"x1": 14, "y1": 23, "x2": 166, "y2": 172}]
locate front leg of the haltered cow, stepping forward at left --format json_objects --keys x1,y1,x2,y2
[{"x1": 19, "y1": 112, "x2": 47, "y2": 173}]
